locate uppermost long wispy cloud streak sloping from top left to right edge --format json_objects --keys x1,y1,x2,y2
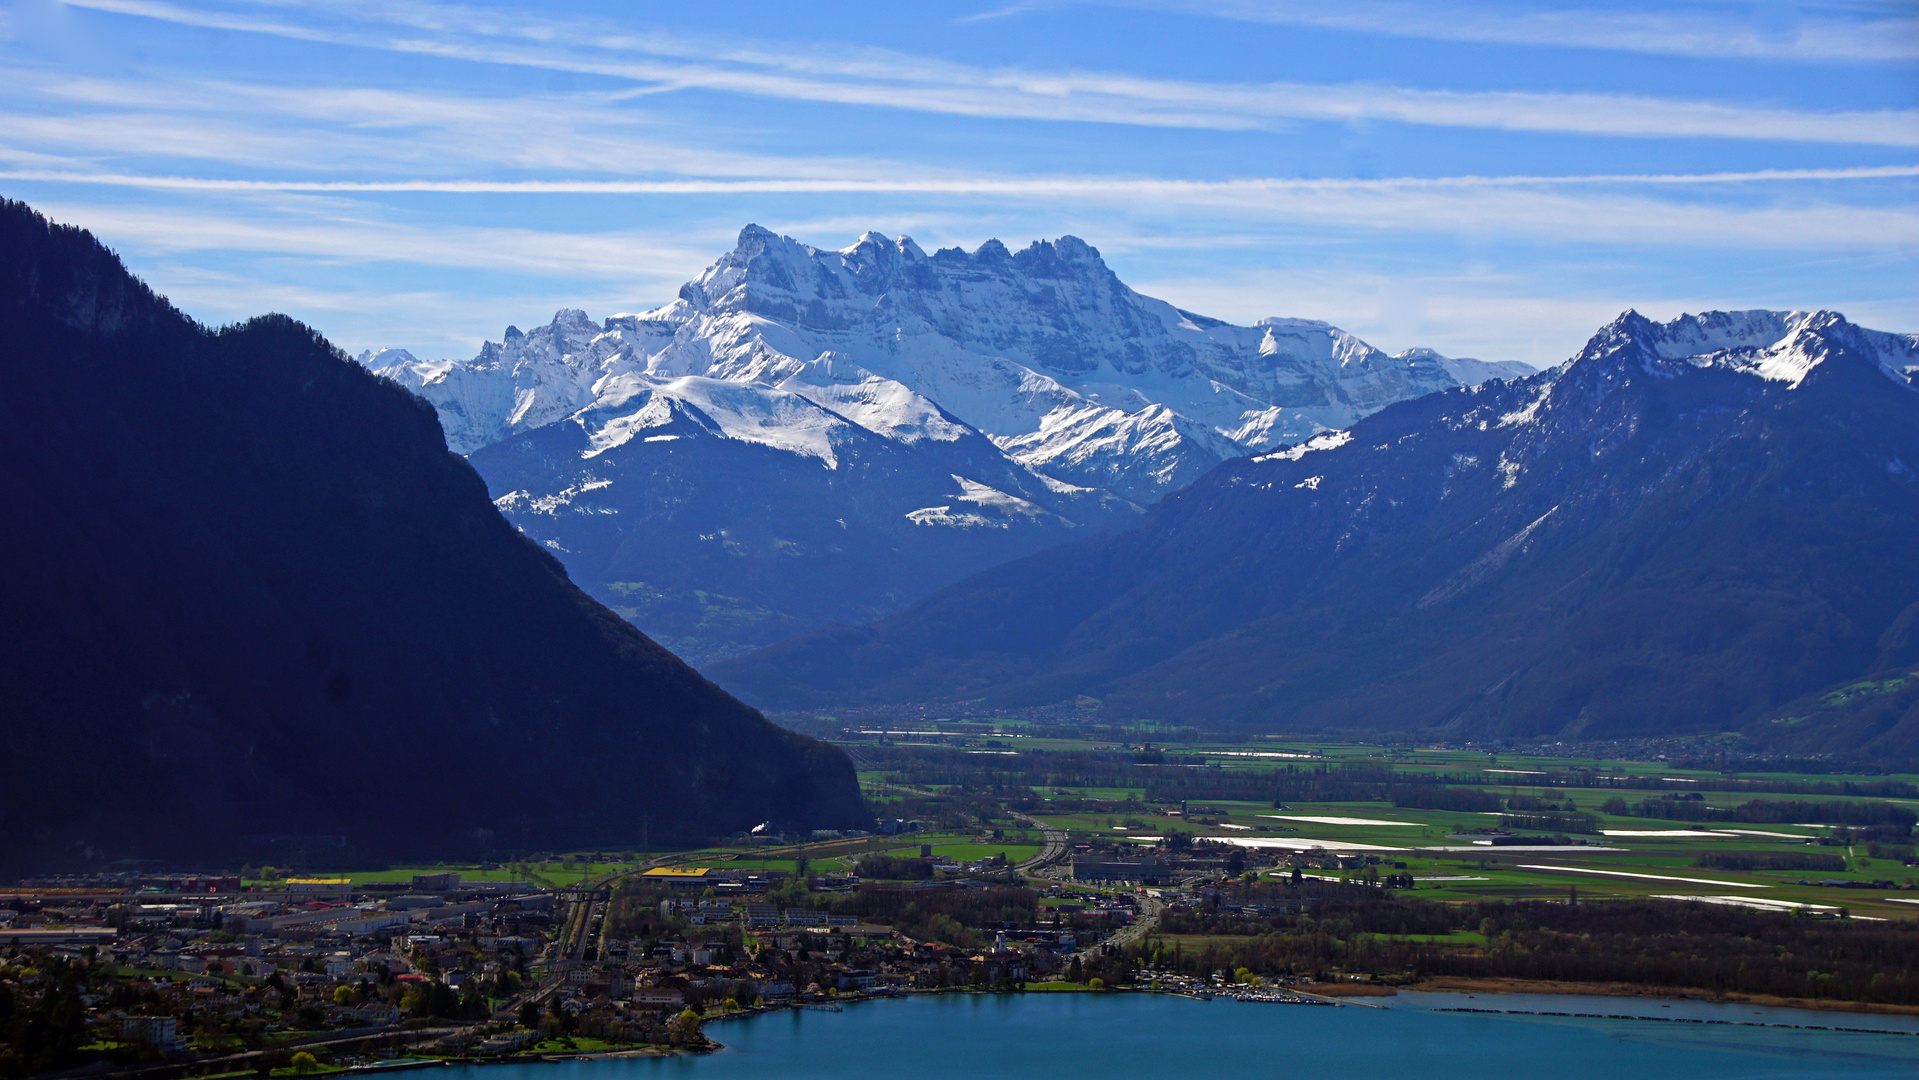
[{"x1": 52, "y1": 0, "x2": 1919, "y2": 148}]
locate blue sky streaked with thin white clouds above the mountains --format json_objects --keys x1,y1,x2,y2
[{"x1": 0, "y1": 0, "x2": 1919, "y2": 364}]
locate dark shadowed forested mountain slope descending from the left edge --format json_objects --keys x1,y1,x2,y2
[{"x1": 0, "y1": 203, "x2": 862, "y2": 865}]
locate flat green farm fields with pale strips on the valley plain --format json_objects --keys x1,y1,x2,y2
[{"x1": 821, "y1": 732, "x2": 1919, "y2": 919}]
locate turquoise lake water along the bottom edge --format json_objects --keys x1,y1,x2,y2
[{"x1": 461, "y1": 994, "x2": 1919, "y2": 1080}]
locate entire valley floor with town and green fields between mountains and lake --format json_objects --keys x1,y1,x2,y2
[{"x1": 11, "y1": 732, "x2": 1919, "y2": 1080}]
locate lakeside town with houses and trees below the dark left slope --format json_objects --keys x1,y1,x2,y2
[{"x1": 0, "y1": 836, "x2": 1376, "y2": 1076}]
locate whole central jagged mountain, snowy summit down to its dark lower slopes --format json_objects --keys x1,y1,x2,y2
[{"x1": 361, "y1": 226, "x2": 1531, "y2": 660}]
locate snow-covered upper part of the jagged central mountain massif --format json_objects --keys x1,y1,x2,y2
[{"x1": 361, "y1": 226, "x2": 1531, "y2": 503}]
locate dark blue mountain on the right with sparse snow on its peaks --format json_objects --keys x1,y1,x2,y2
[{"x1": 712, "y1": 313, "x2": 1919, "y2": 751}]
